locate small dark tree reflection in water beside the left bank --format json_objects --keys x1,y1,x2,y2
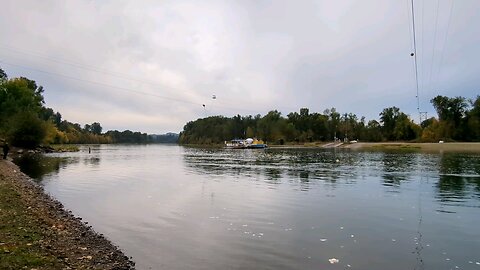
[{"x1": 14, "y1": 154, "x2": 80, "y2": 181}]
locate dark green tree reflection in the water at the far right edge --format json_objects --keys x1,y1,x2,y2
[{"x1": 436, "y1": 153, "x2": 480, "y2": 203}]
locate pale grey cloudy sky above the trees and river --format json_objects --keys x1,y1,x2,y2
[{"x1": 0, "y1": 0, "x2": 480, "y2": 133}]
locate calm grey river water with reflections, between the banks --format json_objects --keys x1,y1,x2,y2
[{"x1": 13, "y1": 145, "x2": 480, "y2": 270}]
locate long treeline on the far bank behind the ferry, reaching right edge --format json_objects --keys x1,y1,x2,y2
[{"x1": 179, "y1": 96, "x2": 480, "y2": 144}]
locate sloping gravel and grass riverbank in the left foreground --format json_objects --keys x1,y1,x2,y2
[{"x1": 0, "y1": 160, "x2": 135, "y2": 269}]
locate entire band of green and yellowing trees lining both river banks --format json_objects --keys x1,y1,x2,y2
[{"x1": 0, "y1": 66, "x2": 480, "y2": 147}]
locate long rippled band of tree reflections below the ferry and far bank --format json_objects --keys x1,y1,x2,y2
[{"x1": 183, "y1": 148, "x2": 480, "y2": 206}]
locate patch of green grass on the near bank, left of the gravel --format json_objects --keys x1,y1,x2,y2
[{"x1": 0, "y1": 176, "x2": 57, "y2": 269}]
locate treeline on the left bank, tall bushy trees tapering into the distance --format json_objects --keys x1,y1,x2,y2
[{"x1": 0, "y1": 68, "x2": 178, "y2": 149}]
